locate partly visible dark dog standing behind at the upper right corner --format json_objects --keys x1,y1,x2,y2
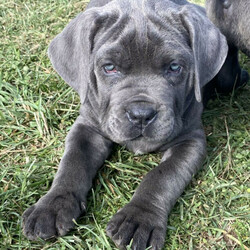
[{"x1": 206, "y1": 0, "x2": 250, "y2": 99}]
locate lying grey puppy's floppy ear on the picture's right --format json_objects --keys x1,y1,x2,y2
[{"x1": 182, "y1": 5, "x2": 228, "y2": 102}]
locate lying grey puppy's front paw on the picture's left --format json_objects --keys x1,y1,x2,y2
[{"x1": 23, "y1": 192, "x2": 84, "y2": 240}]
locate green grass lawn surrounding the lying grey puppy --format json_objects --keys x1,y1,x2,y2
[{"x1": 0, "y1": 0, "x2": 250, "y2": 249}]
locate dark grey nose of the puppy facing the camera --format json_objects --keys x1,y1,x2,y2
[{"x1": 126, "y1": 105, "x2": 157, "y2": 127}]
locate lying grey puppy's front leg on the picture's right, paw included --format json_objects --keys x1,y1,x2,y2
[{"x1": 107, "y1": 130, "x2": 206, "y2": 250}]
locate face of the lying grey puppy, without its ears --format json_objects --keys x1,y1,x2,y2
[{"x1": 93, "y1": 14, "x2": 193, "y2": 153}]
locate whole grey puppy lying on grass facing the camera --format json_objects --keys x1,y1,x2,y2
[{"x1": 23, "y1": 0, "x2": 228, "y2": 249}]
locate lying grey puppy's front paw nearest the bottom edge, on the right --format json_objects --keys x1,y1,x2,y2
[{"x1": 106, "y1": 204, "x2": 167, "y2": 250}]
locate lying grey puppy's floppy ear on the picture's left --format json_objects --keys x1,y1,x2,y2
[{"x1": 48, "y1": 11, "x2": 98, "y2": 103}]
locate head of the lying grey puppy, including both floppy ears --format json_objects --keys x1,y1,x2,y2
[{"x1": 49, "y1": 0, "x2": 227, "y2": 152}]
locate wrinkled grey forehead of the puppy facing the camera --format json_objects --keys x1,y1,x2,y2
[{"x1": 95, "y1": 1, "x2": 192, "y2": 63}]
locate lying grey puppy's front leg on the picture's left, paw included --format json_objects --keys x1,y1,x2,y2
[{"x1": 23, "y1": 117, "x2": 112, "y2": 240}]
